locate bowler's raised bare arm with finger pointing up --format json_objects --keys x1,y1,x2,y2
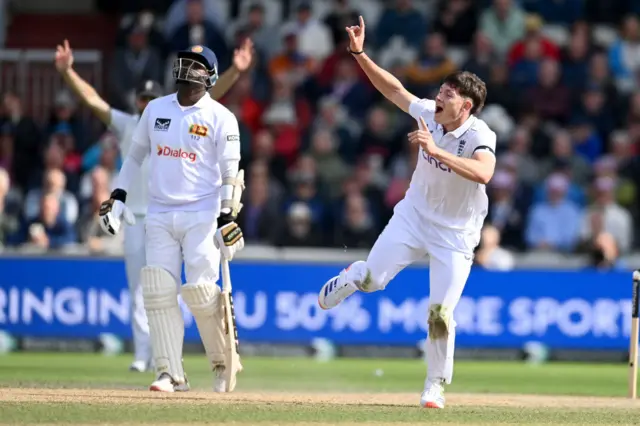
[{"x1": 347, "y1": 16, "x2": 418, "y2": 113}]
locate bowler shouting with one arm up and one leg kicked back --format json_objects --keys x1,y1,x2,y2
[{"x1": 318, "y1": 17, "x2": 496, "y2": 408}]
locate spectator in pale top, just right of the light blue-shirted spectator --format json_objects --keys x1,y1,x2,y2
[{"x1": 581, "y1": 177, "x2": 633, "y2": 253}]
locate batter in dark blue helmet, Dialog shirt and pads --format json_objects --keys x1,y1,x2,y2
[{"x1": 100, "y1": 46, "x2": 244, "y2": 392}]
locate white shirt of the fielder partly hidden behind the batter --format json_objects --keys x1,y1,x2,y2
[{"x1": 109, "y1": 109, "x2": 149, "y2": 215}]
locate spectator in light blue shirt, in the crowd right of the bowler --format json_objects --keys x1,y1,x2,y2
[{"x1": 525, "y1": 174, "x2": 582, "y2": 252}]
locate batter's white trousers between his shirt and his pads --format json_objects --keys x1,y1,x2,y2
[{"x1": 146, "y1": 211, "x2": 220, "y2": 285}]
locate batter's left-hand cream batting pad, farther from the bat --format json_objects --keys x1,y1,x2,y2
[{"x1": 140, "y1": 266, "x2": 186, "y2": 384}]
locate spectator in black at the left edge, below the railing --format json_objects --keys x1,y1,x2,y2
[{"x1": 0, "y1": 92, "x2": 42, "y2": 191}]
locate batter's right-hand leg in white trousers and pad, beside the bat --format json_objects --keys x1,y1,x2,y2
[{"x1": 182, "y1": 212, "x2": 242, "y2": 392}]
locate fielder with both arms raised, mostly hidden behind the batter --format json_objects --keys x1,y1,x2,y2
[{"x1": 55, "y1": 39, "x2": 253, "y2": 372}]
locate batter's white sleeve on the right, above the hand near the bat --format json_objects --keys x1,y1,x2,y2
[{"x1": 216, "y1": 114, "x2": 240, "y2": 200}]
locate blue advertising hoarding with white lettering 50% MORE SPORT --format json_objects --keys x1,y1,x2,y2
[{"x1": 0, "y1": 258, "x2": 631, "y2": 350}]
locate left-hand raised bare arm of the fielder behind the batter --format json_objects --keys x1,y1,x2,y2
[{"x1": 55, "y1": 40, "x2": 111, "y2": 126}]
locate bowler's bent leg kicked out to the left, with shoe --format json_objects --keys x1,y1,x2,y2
[{"x1": 318, "y1": 202, "x2": 426, "y2": 309}]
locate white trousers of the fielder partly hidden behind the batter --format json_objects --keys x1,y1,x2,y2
[{"x1": 124, "y1": 215, "x2": 151, "y2": 363}]
